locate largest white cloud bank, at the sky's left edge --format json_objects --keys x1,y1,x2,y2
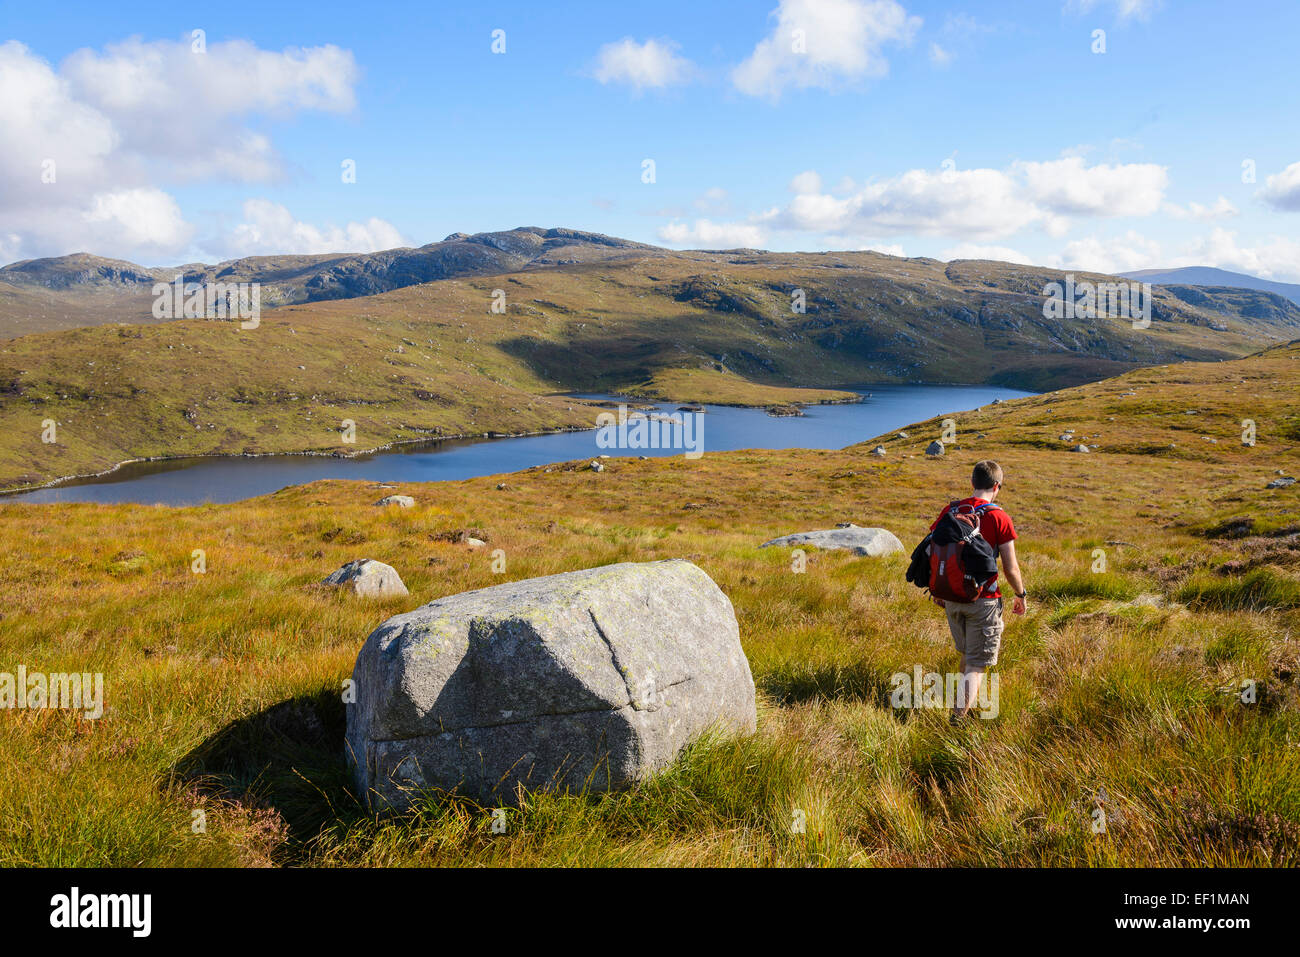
[{"x1": 0, "y1": 38, "x2": 359, "y2": 261}]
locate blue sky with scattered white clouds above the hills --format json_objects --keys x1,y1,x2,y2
[{"x1": 0, "y1": 0, "x2": 1300, "y2": 281}]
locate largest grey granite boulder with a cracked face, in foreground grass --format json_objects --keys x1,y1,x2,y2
[{"x1": 347, "y1": 560, "x2": 757, "y2": 810}]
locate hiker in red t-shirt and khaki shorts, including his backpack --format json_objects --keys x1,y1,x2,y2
[{"x1": 918, "y1": 460, "x2": 1026, "y2": 724}]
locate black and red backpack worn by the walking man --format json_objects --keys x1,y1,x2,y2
[{"x1": 907, "y1": 502, "x2": 997, "y2": 603}]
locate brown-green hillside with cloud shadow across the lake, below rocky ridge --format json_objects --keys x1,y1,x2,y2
[{"x1": 0, "y1": 252, "x2": 1300, "y2": 488}]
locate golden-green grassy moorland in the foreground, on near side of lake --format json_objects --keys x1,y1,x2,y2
[{"x1": 0, "y1": 345, "x2": 1300, "y2": 866}]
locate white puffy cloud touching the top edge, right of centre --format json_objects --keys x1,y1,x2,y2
[{"x1": 732, "y1": 0, "x2": 920, "y2": 99}]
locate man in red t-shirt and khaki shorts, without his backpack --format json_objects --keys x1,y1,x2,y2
[{"x1": 930, "y1": 460, "x2": 1026, "y2": 724}]
